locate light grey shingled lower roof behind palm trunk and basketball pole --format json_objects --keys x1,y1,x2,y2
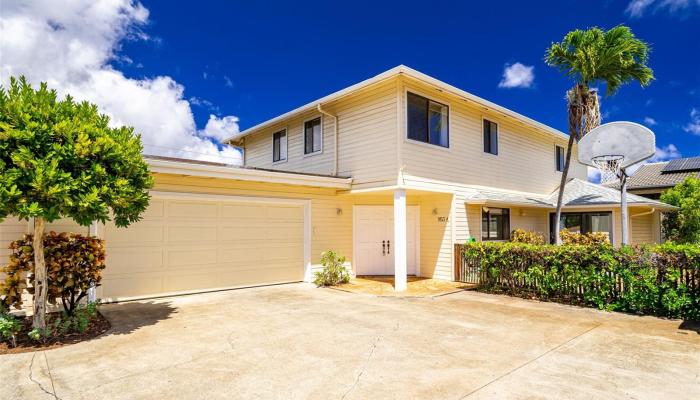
[{"x1": 549, "y1": 178, "x2": 675, "y2": 209}]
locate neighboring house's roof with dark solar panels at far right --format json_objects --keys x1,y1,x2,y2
[{"x1": 605, "y1": 157, "x2": 700, "y2": 190}]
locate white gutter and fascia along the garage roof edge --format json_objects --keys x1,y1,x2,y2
[{"x1": 146, "y1": 159, "x2": 352, "y2": 190}]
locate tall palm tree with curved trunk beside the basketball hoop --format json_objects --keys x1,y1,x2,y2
[{"x1": 544, "y1": 25, "x2": 654, "y2": 243}]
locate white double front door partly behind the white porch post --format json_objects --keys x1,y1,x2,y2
[{"x1": 354, "y1": 206, "x2": 419, "y2": 275}]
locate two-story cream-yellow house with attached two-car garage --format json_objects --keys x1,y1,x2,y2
[{"x1": 0, "y1": 66, "x2": 668, "y2": 299}]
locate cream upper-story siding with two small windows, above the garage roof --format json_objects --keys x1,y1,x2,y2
[{"x1": 245, "y1": 81, "x2": 398, "y2": 184}]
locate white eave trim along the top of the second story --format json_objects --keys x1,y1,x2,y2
[{"x1": 224, "y1": 65, "x2": 569, "y2": 142}]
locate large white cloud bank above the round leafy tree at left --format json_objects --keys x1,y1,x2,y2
[{"x1": 0, "y1": 0, "x2": 241, "y2": 164}]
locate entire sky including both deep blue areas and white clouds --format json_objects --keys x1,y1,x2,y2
[{"x1": 0, "y1": 0, "x2": 700, "y2": 165}]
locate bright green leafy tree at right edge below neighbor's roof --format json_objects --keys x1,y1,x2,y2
[{"x1": 661, "y1": 177, "x2": 700, "y2": 243}]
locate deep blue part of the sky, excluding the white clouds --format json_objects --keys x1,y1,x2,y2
[{"x1": 116, "y1": 1, "x2": 700, "y2": 161}]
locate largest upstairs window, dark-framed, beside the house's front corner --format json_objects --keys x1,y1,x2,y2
[{"x1": 407, "y1": 93, "x2": 450, "y2": 147}]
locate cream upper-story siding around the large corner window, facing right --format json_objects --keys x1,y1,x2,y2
[{"x1": 400, "y1": 81, "x2": 587, "y2": 194}]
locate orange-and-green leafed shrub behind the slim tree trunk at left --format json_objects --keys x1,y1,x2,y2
[{"x1": 0, "y1": 232, "x2": 105, "y2": 315}]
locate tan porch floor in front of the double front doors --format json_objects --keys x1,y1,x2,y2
[{"x1": 334, "y1": 275, "x2": 475, "y2": 297}]
